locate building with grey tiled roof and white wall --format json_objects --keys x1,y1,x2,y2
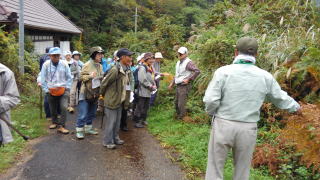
[{"x1": 0, "y1": 0, "x2": 82, "y2": 54}]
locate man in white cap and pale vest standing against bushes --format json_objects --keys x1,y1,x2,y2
[{"x1": 169, "y1": 47, "x2": 200, "y2": 119}]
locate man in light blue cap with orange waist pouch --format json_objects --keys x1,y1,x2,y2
[{"x1": 40, "y1": 47, "x2": 72, "y2": 134}]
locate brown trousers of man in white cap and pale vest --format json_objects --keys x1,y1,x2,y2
[{"x1": 175, "y1": 84, "x2": 191, "y2": 118}]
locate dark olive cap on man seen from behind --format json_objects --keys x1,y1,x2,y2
[{"x1": 236, "y1": 37, "x2": 258, "y2": 55}]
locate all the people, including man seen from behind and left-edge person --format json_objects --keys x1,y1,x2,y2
[{"x1": 0, "y1": 37, "x2": 301, "y2": 180}]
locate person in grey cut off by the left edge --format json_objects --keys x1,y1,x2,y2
[{"x1": 0, "y1": 63, "x2": 20, "y2": 146}]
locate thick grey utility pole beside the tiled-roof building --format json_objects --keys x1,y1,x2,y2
[{"x1": 19, "y1": 0, "x2": 24, "y2": 74}]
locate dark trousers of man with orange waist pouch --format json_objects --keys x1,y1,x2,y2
[{"x1": 48, "y1": 91, "x2": 70, "y2": 126}]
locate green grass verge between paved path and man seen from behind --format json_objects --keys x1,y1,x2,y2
[{"x1": 148, "y1": 102, "x2": 274, "y2": 180}]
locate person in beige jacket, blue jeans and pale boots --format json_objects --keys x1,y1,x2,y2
[{"x1": 76, "y1": 46, "x2": 103, "y2": 139}]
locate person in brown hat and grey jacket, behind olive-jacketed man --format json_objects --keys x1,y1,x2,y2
[{"x1": 133, "y1": 52, "x2": 157, "y2": 128}]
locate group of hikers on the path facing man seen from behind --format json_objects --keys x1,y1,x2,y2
[{"x1": 38, "y1": 46, "x2": 200, "y2": 149}]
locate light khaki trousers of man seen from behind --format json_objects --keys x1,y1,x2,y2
[{"x1": 206, "y1": 118, "x2": 257, "y2": 180}]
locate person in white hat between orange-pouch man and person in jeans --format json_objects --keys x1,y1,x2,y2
[{"x1": 65, "y1": 51, "x2": 80, "y2": 113}]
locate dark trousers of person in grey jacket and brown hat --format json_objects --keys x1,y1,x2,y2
[{"x1": 134, "y1": 96, "x2": 150, "y2": 123}]
